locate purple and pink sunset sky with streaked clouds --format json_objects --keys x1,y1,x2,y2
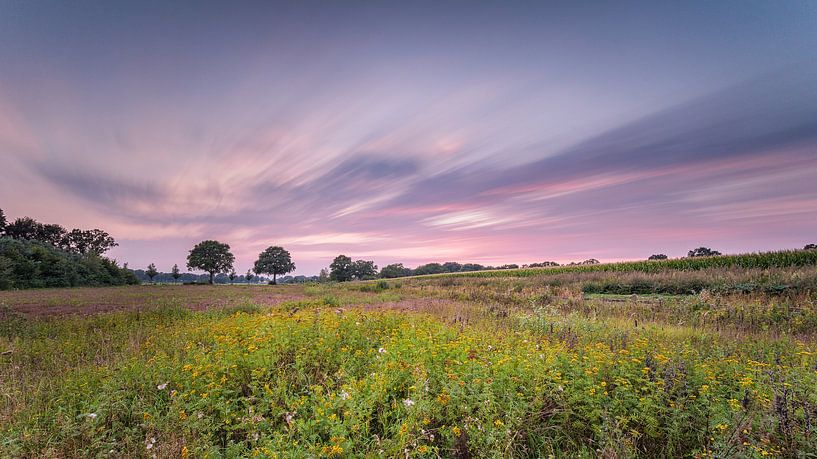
[{"x1": 0, "y1": 0, "x2": 817, "y2": 275}]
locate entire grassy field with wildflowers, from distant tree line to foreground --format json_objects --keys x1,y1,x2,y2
[{"x1": 0, "y1": 262, "x2": 817, "y2": 458}]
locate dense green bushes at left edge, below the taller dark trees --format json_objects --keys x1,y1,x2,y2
[{"x1": 0, "y1": 237, "x2": 138, "y2": 290}]
